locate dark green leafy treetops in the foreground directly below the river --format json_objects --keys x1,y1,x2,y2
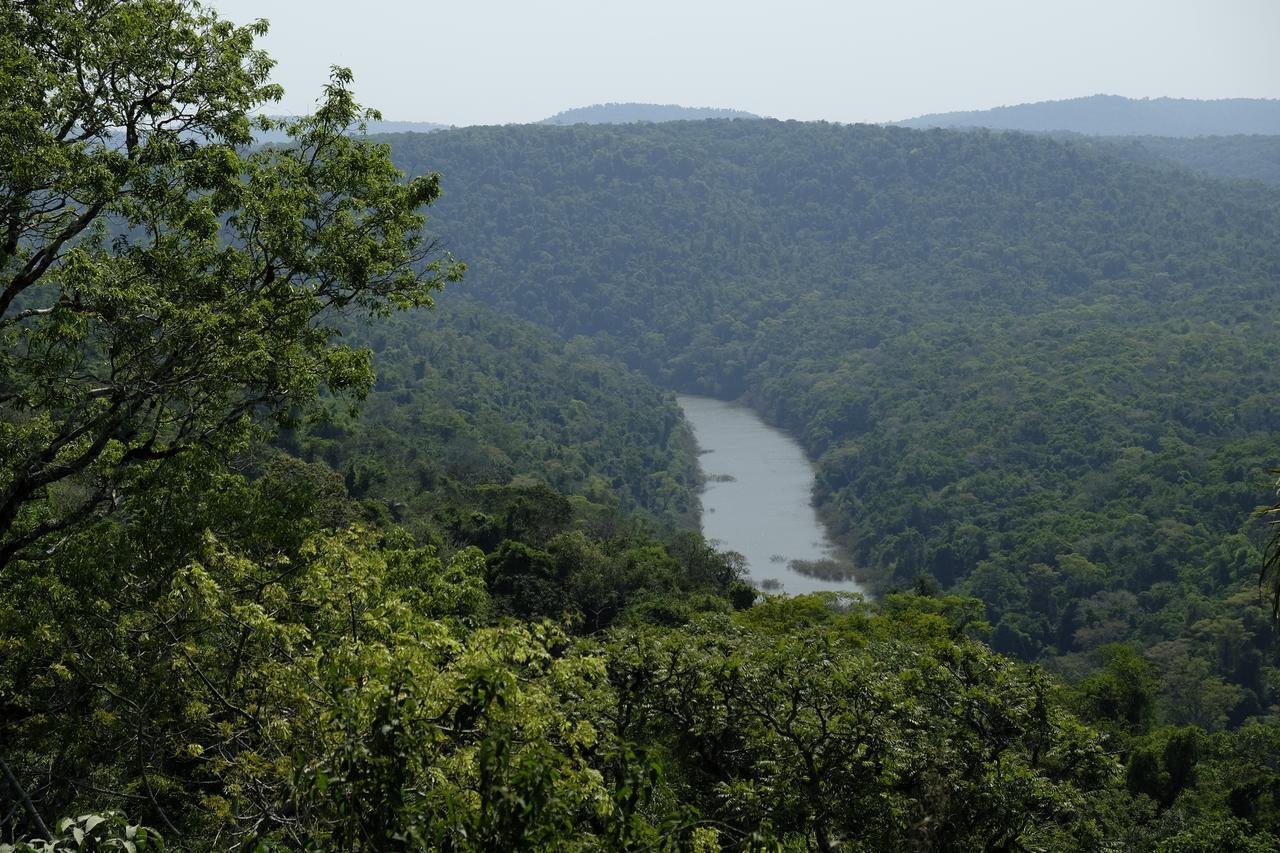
[{"x1": 611, "y1": 599, "x2": 1117, "y2": 850}]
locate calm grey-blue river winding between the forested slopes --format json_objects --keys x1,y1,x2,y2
[{"x1": 676, "y1": 394, "x2": 861, "y2": 596}]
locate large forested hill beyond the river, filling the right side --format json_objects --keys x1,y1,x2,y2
[{"x1": 393, "y1": 122, "x2": 1280, "y2": 727}]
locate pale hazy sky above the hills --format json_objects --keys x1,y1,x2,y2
[{"x1": 207, "y1": 0, "x2": 1280, "y2": 124}]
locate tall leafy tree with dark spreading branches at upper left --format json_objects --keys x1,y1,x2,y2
[{"x1": 0, "y1": 0, "x2": 462, "y2": 576}]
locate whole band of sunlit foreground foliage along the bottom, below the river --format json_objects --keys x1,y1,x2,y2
[{"x1": 4, "y1": 450, "x2": 1146, "y2": 849}]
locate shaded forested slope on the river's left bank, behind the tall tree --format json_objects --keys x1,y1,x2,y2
[{"x1": 279, "y1": 298, "x2": 698, "y2": 535}]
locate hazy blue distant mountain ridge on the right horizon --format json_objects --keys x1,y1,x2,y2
[{"x1": 893, "y1": 95, "x2": 1280, "y2": 137}]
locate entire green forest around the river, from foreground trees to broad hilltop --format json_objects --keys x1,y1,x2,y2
[{"x1": 0, "y1": 0, "x2": 1280, "y2": 853}]
